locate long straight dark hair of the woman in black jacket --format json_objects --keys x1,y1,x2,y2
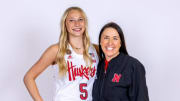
[{"x1": 99, "y1": 22, "x2": 128, "y2": 59}]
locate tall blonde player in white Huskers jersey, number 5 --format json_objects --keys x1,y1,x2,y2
[{"x1": 24, "y1": 7, "x2": 98, "y2": 101}]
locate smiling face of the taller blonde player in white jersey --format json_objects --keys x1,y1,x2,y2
[{"x1": 66, "y1": 10, "x2": 85, "y2": 37}]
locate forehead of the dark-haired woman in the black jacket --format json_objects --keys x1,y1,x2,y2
[{"x1": 102, "y1": 27, "x2": 119, "y2": 36}]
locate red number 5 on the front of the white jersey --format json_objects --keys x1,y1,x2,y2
[{"x1": 79, "y1": 83, "x2": 88, "y2": 100}]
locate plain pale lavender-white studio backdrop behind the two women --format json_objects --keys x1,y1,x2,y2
[{"x1": 0, "y1": 0, "x2": 180, "y2": 101}]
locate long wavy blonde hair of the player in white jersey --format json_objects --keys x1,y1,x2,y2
[{"x1": 56, "y1": 7, "x2": 92, "y2": 76}]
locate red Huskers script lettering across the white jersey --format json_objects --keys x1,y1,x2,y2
[{"x1": 67, "y1": 61, "x2": 96, "y2": 81}]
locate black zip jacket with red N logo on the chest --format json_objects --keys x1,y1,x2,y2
[{"x1": 93, "y1": 53, "x2": 149, "y2": 101}]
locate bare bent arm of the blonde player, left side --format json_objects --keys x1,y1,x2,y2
[{"x1": 24, "y1": 45, "x2": 58, "y2": 101}]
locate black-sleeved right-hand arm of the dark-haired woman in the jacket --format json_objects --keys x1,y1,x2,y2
[{"x1": 129, "y1": 61, "x2": 149, "y2": 101}]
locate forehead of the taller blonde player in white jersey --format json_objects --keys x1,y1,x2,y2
[{"x1": 67, "y1": 10, "x2": 84, "y2": 18}]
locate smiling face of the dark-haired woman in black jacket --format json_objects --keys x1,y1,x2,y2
[{"x1": 100, "y1": 27, "x2": 121, "y2": 61}]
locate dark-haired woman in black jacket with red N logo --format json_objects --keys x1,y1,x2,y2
[{"x1": 93, "y1": 22, "x2": 149, "y2": 101}]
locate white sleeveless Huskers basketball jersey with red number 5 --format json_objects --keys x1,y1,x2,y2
[{"x1": 53, "y1": 45, "x2": 99, "y2": 101}]
